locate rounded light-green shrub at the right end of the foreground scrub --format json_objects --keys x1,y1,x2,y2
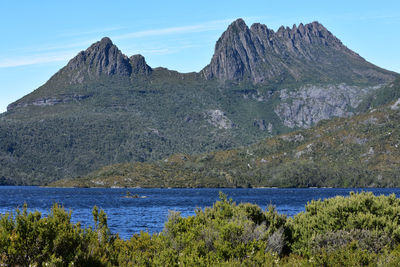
[{"x1": 287, "y1": 193, "x2": 400, "y2": 255}]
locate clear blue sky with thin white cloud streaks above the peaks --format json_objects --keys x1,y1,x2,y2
[{"x1": 0, "y1": 0, "x2": 400, "y2": 112}]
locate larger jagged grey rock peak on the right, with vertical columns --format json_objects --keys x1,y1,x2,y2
[{"x1": 201, "y1": 19, "x2": 394, "y2": 84}]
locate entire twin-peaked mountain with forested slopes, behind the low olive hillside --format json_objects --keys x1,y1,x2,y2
[{"x1": 0, "y1": 19, "x2": 399, "y2": 185}]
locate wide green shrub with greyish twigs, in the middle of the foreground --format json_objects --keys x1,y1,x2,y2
[{"x1": 163, "y1": 194, "x2": 286, "y2": 261}]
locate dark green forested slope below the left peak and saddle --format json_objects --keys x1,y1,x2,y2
[{"x1": 0, "y1": 73, "x2": 294, "y2": 185}]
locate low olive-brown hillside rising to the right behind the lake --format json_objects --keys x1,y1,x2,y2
[{"x1": 53, "y1": 98, "x2": 400, "y2": 187}]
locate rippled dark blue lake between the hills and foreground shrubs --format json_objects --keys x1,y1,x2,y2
[{"x1": 0, "y1": 186, "x2": 400, "y2": 238}]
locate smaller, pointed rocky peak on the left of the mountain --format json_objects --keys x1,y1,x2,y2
[{"x1": 7, "y1": 37, "x2": 152, "y2": 111}]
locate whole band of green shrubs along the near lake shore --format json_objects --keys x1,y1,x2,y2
[{"x1": 0, "y1": 193, "x2": 400, "y2": 266}]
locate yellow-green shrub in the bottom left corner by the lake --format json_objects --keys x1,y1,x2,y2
[{"x1": 0, "y1": 204, "x2": 85, "y2": 266}]
